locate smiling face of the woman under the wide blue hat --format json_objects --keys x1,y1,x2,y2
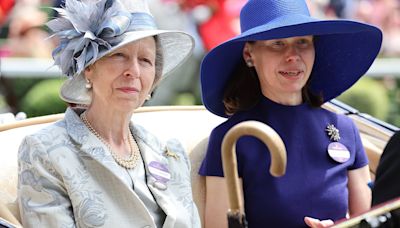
[{"x1": 243, "y1": 36, "x2": 315, "y2": 103}]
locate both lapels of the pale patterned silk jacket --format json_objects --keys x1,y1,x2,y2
[{"x1": 65, "y1": 108, "x2": 176, "y2": 227}]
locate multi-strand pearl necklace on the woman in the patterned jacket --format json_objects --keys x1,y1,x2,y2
[{"x1": 81, "y1": 112, "x2": 140, "y2": 169}]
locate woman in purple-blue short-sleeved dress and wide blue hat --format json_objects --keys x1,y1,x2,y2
[{"x1": 199, "y1": 0, "x2": 382, "y2": 227}]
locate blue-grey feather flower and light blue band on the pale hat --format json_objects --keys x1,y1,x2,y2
[{"x1": 47, "y1": 0, "x2": 157, "y2": 77}]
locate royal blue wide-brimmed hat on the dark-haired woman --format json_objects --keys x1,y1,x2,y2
[{"x1": 201, "y1": 0, "x2": 382, "y2": 117}]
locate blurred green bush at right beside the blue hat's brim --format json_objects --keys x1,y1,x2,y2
[{"x1": 337, "y1": 77, "x2": 390, "y2": 121}]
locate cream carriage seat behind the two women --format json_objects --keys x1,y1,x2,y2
[{"x1": 0, "y1": 106, "x2": 224, "y2": 225}]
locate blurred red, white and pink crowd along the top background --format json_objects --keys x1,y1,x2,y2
[{"x1": 0, "y1": 0, "x2": 400, "y2": 57}]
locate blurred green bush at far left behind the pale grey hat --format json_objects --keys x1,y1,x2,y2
[{"x1": 20, "y1": 79, "x2": 67, "y2": 117}]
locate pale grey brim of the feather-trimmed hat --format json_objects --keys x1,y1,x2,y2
[{"x1": 60, "y1": 30, "x2": 194, "y2": 105}]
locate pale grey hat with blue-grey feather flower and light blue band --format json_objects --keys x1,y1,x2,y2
[{"x1": 47, "y1": 0, "x2": 194, "y2": 105}]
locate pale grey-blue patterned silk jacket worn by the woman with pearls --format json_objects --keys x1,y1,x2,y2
[{"x1": 18, "y1": 108, "x2": 200, "y2": 228}]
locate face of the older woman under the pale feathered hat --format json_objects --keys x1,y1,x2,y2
[{"x1": 85, "y1": 37, "x2": 156, "y2": 112}]
